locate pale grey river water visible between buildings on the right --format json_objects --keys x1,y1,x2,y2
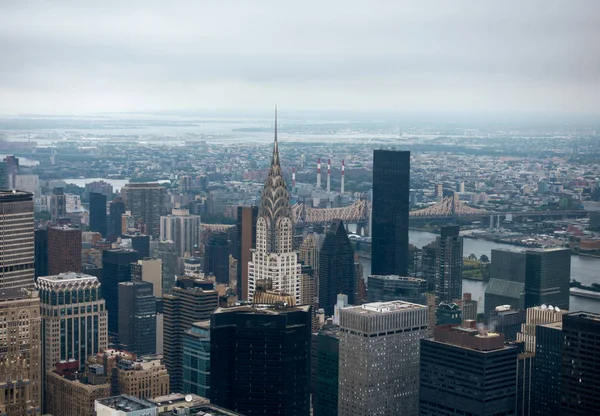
[{"x1": 360, "y1": 230, "x2": 600, "y2": 313}]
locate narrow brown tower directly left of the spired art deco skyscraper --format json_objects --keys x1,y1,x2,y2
[{"x1": 236, "y1": 206, "x2": 258, "y2": 300}]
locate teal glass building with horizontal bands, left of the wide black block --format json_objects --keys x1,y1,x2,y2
[{"x1": 183, "y1": 321, "x2": 210, "y2": 398}]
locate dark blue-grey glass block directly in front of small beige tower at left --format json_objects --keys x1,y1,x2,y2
[{"x1": 119, "y1": 282, "x2": 156, "y2": 356}]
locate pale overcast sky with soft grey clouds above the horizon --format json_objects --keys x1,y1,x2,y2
[{"x1": 0, "y1": 0, "x2": 600, "y2": 115}]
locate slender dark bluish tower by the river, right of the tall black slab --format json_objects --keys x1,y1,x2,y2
[{"x1": 435, "y1": 226, "x2": 463, "y2": 302}]
